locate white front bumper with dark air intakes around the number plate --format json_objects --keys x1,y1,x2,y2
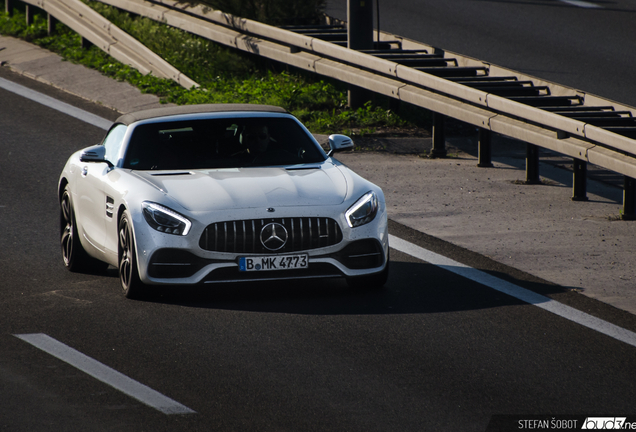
[{"x1": 133, "y1": 202, "x2": 389, "y2": 285}]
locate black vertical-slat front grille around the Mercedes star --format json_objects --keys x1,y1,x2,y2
[{"x1": 199, "y1": 217, "x2": 342, "y2": 254}]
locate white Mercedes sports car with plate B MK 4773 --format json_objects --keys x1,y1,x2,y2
[{"x1": 58, "y1": 104, "x2": 389, "y2": 297}]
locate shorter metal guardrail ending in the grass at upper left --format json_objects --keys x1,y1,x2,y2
[{"x1": 16, "y1": 0, "x2": 199, "y2": 88}]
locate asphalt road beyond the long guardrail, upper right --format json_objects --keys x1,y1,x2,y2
[{"x1": 327, "y1": 0, "x2": 636, "y2": 106}]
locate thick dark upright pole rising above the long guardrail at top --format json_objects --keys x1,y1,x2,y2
[{"x1": 347, "y1": 0, "x2": 373, "y2": 109}]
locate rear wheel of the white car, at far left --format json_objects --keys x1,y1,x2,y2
[{"x1": 60, "y1": 186, "x2": 108, "y2": 273}]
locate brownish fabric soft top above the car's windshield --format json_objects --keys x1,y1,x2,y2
[{"x1": 115, "y1": 104, "x2": 287, "y2": 125}]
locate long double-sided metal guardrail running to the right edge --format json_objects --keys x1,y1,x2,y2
[{"x1": 8, "y1": 0, "x2": 636, "y2": 216}]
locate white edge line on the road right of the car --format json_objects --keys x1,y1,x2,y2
[{"x1": 389, "y1": 235, "x2": 636, "y2": 347}]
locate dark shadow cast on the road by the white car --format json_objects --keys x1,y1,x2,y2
[{"x1": 144, "y1": 260, "x2": 566, "y2": 315}]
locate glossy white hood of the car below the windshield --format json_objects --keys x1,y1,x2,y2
[{"x1": 135, "y1": 163, "x2": 347, "y2": 211}]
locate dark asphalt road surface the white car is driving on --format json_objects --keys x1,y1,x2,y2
[{"x1": 0, "y1": 72, "x2": 636, "y2": 432}]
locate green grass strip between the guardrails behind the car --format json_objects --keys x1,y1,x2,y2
[{"x1": 0, "y1": 1, "x2": 428, "y2": 135}]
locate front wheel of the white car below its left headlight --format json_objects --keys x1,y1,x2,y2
[{"x1": 118, "y1": 212, "x2": 144, "y2": 299}]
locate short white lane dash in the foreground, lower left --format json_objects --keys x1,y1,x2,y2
[{"x1": 15, "y1": 333, "x2": 195, "y2": 414}]
